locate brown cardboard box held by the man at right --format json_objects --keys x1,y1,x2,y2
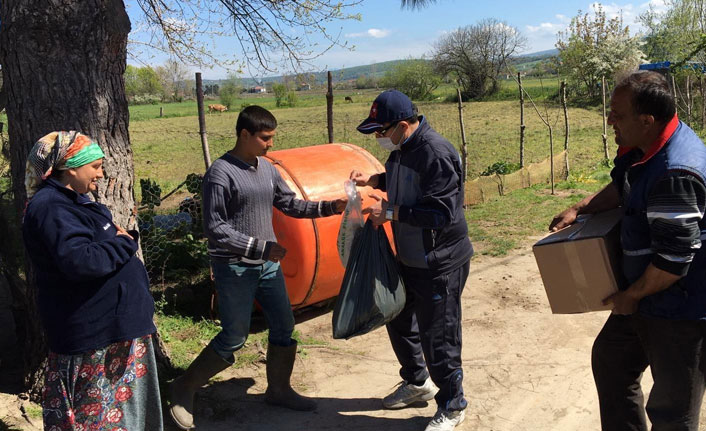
[{"x1": 532, "y1": 208, "x2": 624, "y2": 314}]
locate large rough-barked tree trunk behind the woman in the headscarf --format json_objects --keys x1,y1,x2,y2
[{"x1": 0, "y1": 0, "x2": 135, "y2": 400}]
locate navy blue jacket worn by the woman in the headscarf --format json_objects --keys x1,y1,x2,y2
[{"x1": 22, "y1": 178, "x2": 156, "y2": 354}]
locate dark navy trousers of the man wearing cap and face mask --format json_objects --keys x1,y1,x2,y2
[{"x1": 387, "y1": 262, "x2": 470, "y2": 410}]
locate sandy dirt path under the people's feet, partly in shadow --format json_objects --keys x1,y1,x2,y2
[{"x1": 5, "y1": 247, "x2": 706, "y2": 431}]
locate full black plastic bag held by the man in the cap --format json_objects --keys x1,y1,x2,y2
[{"x1": 333, "y1": 220, "x2": 406, "y2": 339}]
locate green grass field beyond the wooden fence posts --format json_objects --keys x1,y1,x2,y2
[{"x1": 130, "y1": 78, "x2": 602, "y2": 190}]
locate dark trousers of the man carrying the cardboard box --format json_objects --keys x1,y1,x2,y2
[{"x1": 591, "y1": 314, "x2": 706, "y2": 431}]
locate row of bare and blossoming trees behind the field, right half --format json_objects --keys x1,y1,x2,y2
[{"x1": 356, "y1": 0, "x2": 706, "y2": 109}]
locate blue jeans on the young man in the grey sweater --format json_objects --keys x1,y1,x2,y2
[{"x1": 210, "y1": 261, "x2": 294, "y2": 361}]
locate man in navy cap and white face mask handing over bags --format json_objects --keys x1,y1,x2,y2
[{"x1": 351, "y1": 90, "x2": 473, "y2": 431}]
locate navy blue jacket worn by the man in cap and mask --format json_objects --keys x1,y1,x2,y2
[{"x1": 378, "y1": 116, "x2": 473, "y2": 274}]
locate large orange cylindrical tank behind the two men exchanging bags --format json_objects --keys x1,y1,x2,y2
[{"x1": 266, "y1": 144, "x2": 390, "y2": 309}]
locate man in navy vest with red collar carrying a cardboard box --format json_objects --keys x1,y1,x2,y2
[{"x1": 550, "y1": 72, "x2": 706, "y2": 431}]
